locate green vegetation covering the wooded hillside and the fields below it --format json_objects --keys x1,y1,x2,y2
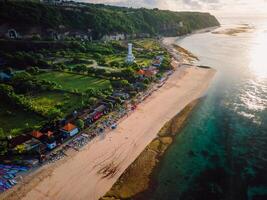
[{"x1": 0, "y1": 1, "x2": 219, "y2": 149}]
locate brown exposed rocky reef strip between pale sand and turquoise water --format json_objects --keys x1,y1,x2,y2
[{"x1": 100, "y1": 99, "x2": 201, "y2": 200}]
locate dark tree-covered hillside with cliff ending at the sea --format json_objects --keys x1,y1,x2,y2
[{"x1": 0, "y1": 1, "x2": 219, "y2": 39}]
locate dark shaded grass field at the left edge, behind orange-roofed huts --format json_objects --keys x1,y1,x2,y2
[{"x1": 0, "y1": 101, "x2": 45, "y2": 136}]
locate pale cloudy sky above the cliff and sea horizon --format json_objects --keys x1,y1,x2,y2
[{"x1": 81, "y1": 0, "x2": 267, "y2": 16}]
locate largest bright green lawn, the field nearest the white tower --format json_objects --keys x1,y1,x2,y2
[{"x1": 37, "y1": 72, "x2": 110, "y2": 92}]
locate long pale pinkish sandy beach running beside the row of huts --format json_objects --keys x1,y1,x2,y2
[{"x1": 1, "y1": 39, "x2": 215, "y2": 200}]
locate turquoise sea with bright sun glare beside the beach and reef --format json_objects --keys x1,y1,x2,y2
[{"x1": 141, "y1": 19, "x2": 267, "y2": 200}]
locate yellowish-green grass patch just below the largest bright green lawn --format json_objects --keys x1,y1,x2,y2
[{"x1": 29, "y1": 91, "x2": 82, "y2": 115}]
